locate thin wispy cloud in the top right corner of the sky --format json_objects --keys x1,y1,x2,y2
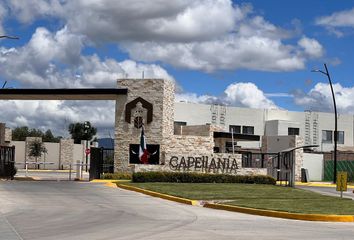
[{"x1": 316, "y1": 8, "x2": 354, "y2": 37}]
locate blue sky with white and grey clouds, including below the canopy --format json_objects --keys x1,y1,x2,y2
[{"x1": 0, "y1": 0, "x2": 354, "y2": 137}]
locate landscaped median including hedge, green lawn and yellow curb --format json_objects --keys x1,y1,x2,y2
[{"x1": 98, "y1": 172, "x2": 354, "y2": 222}]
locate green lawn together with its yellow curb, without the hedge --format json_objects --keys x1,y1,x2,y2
[{"x1": 117, "y1": 182, "x2": 354, "y2": 222}]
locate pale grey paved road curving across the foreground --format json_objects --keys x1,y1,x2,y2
[{"x1": 0, "y1": 181, "x2": 354, "y2": 240}]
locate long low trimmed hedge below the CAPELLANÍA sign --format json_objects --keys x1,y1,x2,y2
[{"x1": 132, "y1": 172, "x2": 276, "y2": 185}]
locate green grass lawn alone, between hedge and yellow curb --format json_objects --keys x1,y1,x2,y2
[{"x1": 127, "y1": 183, "x2": 354, "y2": 215}]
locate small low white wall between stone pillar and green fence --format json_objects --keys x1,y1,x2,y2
[{"x1": 302, "y1": 153, "x2": 323, "y2": 181}]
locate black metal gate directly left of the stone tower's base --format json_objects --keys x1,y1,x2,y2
[{"x1": 89, "y1": 148, "x2": 114, "y2": 180}]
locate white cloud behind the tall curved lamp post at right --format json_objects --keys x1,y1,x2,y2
[{"x1": 294, "y1": 83, "x2": 354, "y2": 114}]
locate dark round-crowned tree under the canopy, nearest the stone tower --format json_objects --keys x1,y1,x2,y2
[{"x1": 68, "y1": 122, "x2": 97, "y2": 143}]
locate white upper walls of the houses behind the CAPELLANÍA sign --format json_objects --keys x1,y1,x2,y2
[{"x1": 174, "y1": 102, "x2": 354, "y2": 151}]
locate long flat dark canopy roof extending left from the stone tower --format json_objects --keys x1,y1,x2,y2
[{"x1": 0, "y1": 88, "x2": 128, "y2": 100}]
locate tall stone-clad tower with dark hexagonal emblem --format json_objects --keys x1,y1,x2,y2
[{"x1": 114, "y1": 79, "x2": 174, "y2": 172}]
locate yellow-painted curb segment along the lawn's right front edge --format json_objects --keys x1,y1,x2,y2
[{"x1": 204, "y1": 203, "x2": 354, "y2": 222}]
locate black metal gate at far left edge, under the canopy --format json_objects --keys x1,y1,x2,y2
[{"x1": 0, "y1": 146, "x2": 16, "y2": 179}]
